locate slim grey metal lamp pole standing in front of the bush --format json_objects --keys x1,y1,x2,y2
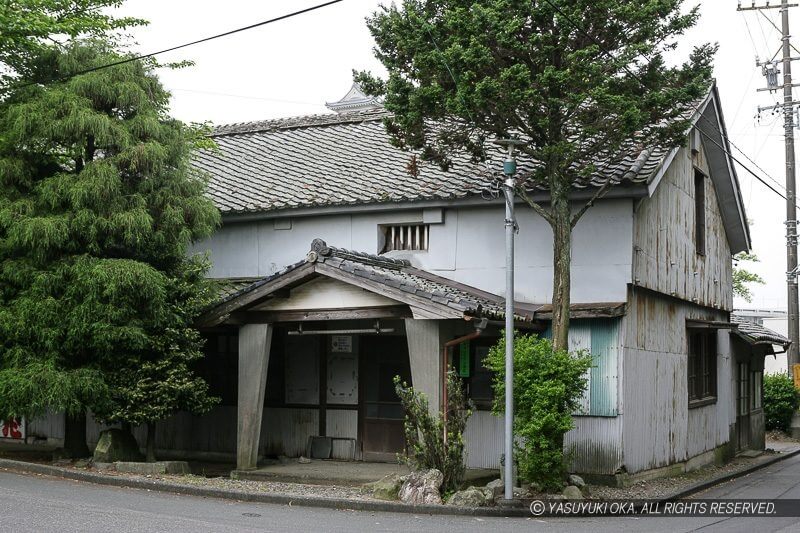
[{"x1": 495, "y1": 135, "x2": 523, "y2": 501}]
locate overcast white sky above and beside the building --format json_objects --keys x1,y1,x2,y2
[{"x1": 121, "y1": 0, "x2": 800, "y2": 309}]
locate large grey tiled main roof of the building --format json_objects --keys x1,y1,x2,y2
[{"x1": 194, "y1": 103, "x2": 669, "y2": 214}]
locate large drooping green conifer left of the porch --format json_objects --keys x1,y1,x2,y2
[{"x1": 0, "y1": 40, "x2": 219, "y2": 458}]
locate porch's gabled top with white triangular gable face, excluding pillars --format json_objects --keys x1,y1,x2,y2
[{"x1": 198, "y1": 239, "x2": 545, "y2": 328}]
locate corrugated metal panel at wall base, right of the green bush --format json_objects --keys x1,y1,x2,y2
[{"x1": 564, "y1": 416, "x2": 623, "y2": 474}]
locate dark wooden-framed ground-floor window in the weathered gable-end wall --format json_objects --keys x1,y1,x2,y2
[{"x1": 686, "y1": 328, "x2": 718, "y2": 408}]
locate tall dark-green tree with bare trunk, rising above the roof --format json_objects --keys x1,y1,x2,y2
[{"x1": 355, "y1": 0, "x2": 716, "y2": 349}]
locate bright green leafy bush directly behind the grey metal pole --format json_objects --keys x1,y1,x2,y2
[{"x1": 484, "y1": 334, "x2": 592, "y2": 490}]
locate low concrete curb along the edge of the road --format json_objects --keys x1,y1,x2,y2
[{"x1": 0, "y1": 449, "x2": 800, "y2": 518}]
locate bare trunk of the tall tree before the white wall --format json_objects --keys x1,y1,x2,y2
[{"x1": 551, "y1": 193, "x2": 572, "y2": 350}]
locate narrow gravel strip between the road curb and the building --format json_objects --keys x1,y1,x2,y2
[{"x1": 1, "y1": 437, "x2": 797, "y2": 501}]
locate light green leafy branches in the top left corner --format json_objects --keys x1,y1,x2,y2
[{"x1": 0, "y1": 0, "x2": 146, "y2": 87}]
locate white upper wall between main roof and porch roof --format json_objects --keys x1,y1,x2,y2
[{"x1": 195, "y1": 199, "x2": 633, "y2": 303}]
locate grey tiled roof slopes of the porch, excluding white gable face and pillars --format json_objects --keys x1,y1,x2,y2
[{"x1": 199, "y1": 239, "x2": 625, "y2": 326}]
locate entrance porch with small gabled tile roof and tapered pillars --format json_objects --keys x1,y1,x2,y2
[{"x1": 198, "y1": 239, "x2": 625, "y2": 470}]
